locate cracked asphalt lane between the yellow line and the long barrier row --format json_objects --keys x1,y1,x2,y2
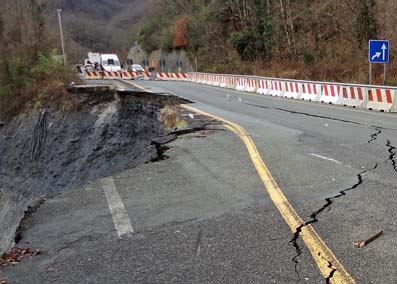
[{"x1": 128, "y1": 82, "x2": 397, "y2": 283}]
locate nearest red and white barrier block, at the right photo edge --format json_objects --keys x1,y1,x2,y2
[{"x1": 366, "y1": 88, "x2": 397, "y2": 112}]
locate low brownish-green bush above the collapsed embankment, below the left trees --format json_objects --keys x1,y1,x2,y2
[{"x1": 0, "y1": 50, "x2": 78, "y2": 118}]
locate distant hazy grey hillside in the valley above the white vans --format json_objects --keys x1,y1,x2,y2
[{"x1": 49, "y1": 0, "x2": 145, "y2": 60}]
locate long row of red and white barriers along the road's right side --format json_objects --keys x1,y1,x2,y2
[{"x1": 187, "y1": 72, "x2": 397, "y2": 112}]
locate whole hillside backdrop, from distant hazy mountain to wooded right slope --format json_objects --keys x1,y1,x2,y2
[{"x1": 0, "y1": 0, "x2": 397, "y2": 84}]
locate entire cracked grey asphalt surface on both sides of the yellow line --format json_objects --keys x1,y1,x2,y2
[{"x1": 0, "y1": 82, "x2": 397, "y2": 283}]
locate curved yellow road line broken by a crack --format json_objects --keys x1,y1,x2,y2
[{"x1": 120, "y1": 79, "x2": 356, "y2": 284}]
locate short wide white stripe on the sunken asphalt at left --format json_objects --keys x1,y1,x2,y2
[{"x1": 101, "y1": 177, "x2": 134, "y2": 239}]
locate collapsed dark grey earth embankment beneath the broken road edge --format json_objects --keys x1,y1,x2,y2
[{"x1": 0, "y1": 88, "x2": 187, "y2": 254}]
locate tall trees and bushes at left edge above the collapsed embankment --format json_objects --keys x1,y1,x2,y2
[{"x1": 0, "y1": 0, "x2": 75, "y2": 118}]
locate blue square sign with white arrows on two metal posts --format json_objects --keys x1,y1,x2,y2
[{"x1": 368, "y1": 40, "x2": 389, "y2": 85}]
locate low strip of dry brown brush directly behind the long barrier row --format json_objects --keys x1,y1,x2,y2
[{"x1": 201, "y1": 40, "x2": 397, "y2": 85}]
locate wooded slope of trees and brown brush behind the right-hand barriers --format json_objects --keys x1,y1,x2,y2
[{"x1": 139, "y1": 0, "x2": 397, "y2": 83}]
